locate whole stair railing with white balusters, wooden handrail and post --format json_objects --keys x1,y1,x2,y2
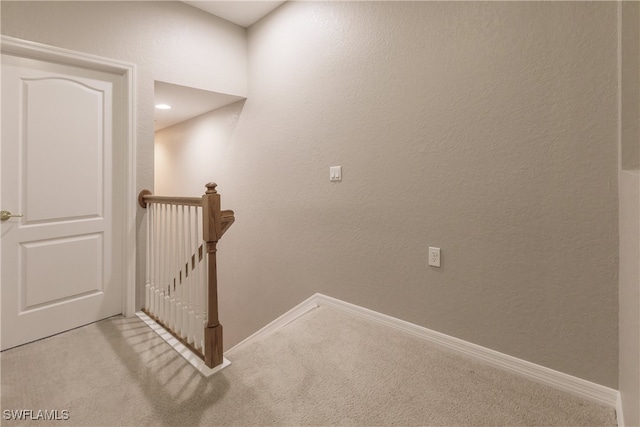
[{"x1": 138, "y1": 183, "x2": 235, "y2": 368}]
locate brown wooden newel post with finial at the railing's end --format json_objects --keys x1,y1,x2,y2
[{"x1": 202, "y1": 183, "x2": 223, "y2": 368}]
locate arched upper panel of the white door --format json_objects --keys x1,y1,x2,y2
[{"x1": 20, "y1": 78, "x2": 106, "y2": 223}]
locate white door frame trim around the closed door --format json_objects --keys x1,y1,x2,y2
[{"x1": 0, "y1": 35, "x2": 137, "y2": 317}]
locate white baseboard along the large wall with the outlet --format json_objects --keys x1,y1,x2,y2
[{"x1": 229, "y1": 294, "x2": 622, "y2": 412}]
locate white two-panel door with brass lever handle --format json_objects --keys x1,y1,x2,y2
[{"x1": 0, "y1": 55, "x2": 123, "y2": 350}]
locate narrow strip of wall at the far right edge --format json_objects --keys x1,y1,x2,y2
[{"x1": 619, "y1": 2, "x2": 640, "y2": 426}]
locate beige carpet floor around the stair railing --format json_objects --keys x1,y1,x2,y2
[{"x1": 0, "y1": 307, "x2": 616, "y2": 426}]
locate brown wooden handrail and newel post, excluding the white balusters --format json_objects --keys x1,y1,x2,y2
[{"x1": 138, "y1": 183, "x2": 235, "y2": 368}]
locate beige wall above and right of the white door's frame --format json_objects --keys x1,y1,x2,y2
[{"x1": 0, "y1": 0, "x2": 247, "y2": 310}]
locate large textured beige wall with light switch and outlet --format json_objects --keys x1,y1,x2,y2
[{"x1": 216, "y1": 2, "x2": 618, "y2": 388}]
